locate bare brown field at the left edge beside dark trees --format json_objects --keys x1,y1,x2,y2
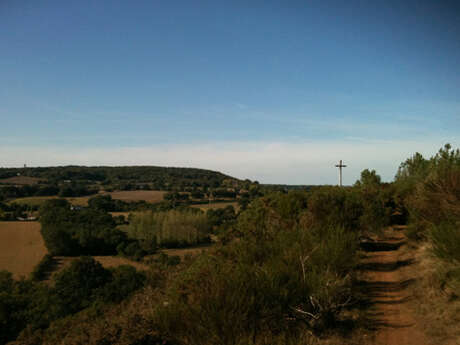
[{"x1": 0, "y1": 222, "x2": 47, "y2": 279}]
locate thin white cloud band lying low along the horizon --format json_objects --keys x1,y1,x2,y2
[{"x1": 0, "y1": 139, "x2": 457, "y2": 184}]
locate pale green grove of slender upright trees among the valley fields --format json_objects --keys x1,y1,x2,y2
[{"x1": 128, "y1": 210, "x2": 211, "y2": 248}]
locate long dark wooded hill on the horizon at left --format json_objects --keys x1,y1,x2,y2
[{"x1": 0, "y1": 166, "x2": 244, "y2": 198}]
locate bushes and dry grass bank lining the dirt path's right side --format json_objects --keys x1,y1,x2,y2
[{"x1": 395, "y1": 145, "x2": 460, "y2": 344}]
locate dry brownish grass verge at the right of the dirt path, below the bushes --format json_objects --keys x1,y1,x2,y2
[{"x1": 411, "y1": 244, "x2": 460, "y2": 345}]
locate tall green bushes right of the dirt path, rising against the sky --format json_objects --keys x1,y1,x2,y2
[{"x1": 395, "y1": 144, "x2": 460, "y2": 281}]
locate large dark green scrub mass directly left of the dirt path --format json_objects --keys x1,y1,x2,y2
[{"x1": 154, "y1": 194, "x2": 357, "y2": 345}]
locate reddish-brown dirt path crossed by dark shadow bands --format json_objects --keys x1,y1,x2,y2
[{"x1": 361, "y1": 228, "x2": 429, "y2": 345}]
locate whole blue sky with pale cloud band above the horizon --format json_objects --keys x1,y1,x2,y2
[{"x1": 0, "y1": 0, "x2": 460, "y2": 184}]
